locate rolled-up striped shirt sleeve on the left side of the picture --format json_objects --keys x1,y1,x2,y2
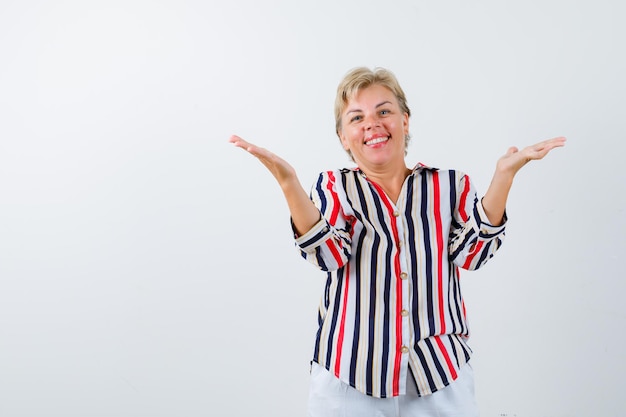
[{"x1": 292, "y1": 172, "x2": 352, "y2": 271}]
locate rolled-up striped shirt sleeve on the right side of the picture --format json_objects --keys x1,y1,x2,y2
[{"x1": 450, "y1": 174, "x2": 507, "y2": 270}]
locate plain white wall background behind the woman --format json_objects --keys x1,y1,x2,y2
[{"x1": 0, "y1": 0, "x2": 626, "y2": 417}]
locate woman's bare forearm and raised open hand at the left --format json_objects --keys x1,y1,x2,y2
[{"x1": 229, "y1": 135, "x2": 321, "y2": 235}]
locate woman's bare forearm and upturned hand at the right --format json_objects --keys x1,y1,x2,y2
[{"x1": 482, "y1": 137, "x2": 565, "y2": 226}]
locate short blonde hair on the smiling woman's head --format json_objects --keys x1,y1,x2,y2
[{"x1": 335, "y1": 67, "x2": 411, "y2": 158}]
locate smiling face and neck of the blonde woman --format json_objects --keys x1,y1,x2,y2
[{"x1": 339, "y1": 84, "x2": 409, "y2": 169}]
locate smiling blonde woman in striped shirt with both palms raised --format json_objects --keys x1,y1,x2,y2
[{"x1": 230, "y1": 68, "x2": 565, "y2": 417}]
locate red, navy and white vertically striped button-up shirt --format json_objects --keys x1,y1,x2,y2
[{"x1": 295, "y1": 164, "x2": 506, "y2": 398}]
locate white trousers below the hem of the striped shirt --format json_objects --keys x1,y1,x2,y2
[{"x1": 308, "y1": 362, "x2": 479, "y2": 417}]
